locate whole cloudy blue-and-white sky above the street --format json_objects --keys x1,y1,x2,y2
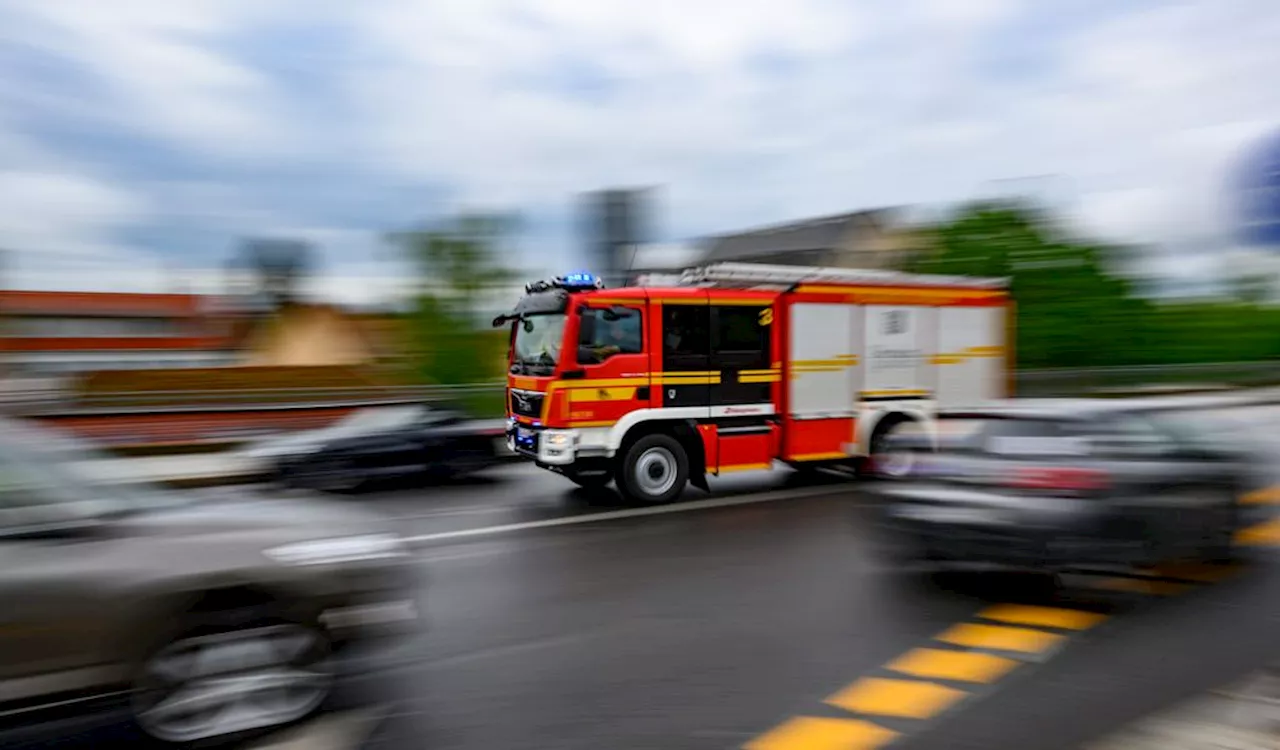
[{"x1": 0, "y1": 0, "x2": 1280, "y2": 301}]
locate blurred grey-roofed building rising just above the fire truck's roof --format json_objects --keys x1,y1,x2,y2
[{"x1": 700, "y1": 209, "x2": 925, "y2": 270}]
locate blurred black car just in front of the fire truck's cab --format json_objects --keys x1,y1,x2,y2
[{"x1": 247, "y1": 404, "x2": 506, "y2": 491}]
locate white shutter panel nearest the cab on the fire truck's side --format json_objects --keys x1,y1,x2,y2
[{"x1": 786, "y1": 303, "x2": 861, "y2": 419}]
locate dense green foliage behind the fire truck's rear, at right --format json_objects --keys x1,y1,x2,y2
[{"x1": 909, "y1": 203, "x2": 1280, "y2": 370}]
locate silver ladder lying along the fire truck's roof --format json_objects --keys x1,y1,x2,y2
[{"x1": 680, "y1": 262, "x2": 1009, "y2": 289}]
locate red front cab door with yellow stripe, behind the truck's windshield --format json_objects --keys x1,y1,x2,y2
[{"x1": 561, "y1": 298, "x2": 652, "y2": 427}]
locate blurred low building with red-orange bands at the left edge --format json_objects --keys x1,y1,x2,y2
[{"x1": 0, "y1": 291, "x2": 236, "y2": 376}]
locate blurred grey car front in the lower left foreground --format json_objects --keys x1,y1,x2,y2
[{"x1": 0, "y1": 420, "x2": 420, "y2": 746}]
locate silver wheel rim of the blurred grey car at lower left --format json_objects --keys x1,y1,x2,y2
[{"x1": 133, "y1": 626, "x2": 333, "y2": 742}]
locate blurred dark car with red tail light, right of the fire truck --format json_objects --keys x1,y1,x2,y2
[{"x1": 877, "y1": 399, "x2": 1261, "y2": 570}]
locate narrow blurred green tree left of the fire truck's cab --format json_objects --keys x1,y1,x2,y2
[{"x1": 388, "y1": 214, "x2": 520, "y2": 391}]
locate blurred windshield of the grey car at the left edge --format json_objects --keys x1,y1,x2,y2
[{"x1": 0, "y1": 420, "x2": 188, "y2": 526}]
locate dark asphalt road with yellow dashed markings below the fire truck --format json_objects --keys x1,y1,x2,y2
[{"x1": 22, "y1": 401, "x2": 1280, "y2": 750}]
